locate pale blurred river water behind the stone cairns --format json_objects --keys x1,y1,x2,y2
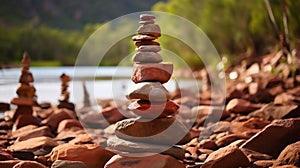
[{"x1": 0, "y1": 67, "x2": 197, "y2": 103}]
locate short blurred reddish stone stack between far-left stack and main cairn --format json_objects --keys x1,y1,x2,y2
[{"x1": 57, "y1": 73, "x2": 75, "y2": 111}]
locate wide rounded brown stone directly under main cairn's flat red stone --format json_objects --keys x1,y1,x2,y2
[{"x1": 115, "y1": 117, "x2": 191, "y2": 145}]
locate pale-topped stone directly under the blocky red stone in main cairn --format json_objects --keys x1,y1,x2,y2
[{"x1": 126, "y1": 82, "x2": 170, "y2": 102}]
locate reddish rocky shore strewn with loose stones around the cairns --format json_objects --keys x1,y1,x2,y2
[{"x1": 0, "y1": 51, "x2": 300, "y2": 168}]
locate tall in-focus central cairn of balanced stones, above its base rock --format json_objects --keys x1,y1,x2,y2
[{"x1": 107, "y1": 14, "x2": 190, "y2": 159}]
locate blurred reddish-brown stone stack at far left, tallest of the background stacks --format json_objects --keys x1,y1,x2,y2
[{"x1": 11, "y1": 52, "x2": 37, "y2": 121}]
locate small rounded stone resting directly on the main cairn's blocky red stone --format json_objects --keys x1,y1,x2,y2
[{"x1": 132, "y1": 52, "x2": 163, "y2": 63}]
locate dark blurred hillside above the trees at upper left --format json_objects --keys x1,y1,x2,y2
[{"x1": 0, "y1": 0, "x2": 166, "y2": 29}]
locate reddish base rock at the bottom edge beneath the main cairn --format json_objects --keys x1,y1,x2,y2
[{"x1": 104, "y1": 154, "x2": 185, "y2": 168}]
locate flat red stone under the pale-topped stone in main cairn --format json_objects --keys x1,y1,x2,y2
[{"x1": 128, "y1": 100, "x2": 179, "y2": 118}]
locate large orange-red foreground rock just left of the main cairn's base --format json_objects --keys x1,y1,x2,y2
[{"x1": 50, "y1": 143, "x2": 114, "y2": 168}]
